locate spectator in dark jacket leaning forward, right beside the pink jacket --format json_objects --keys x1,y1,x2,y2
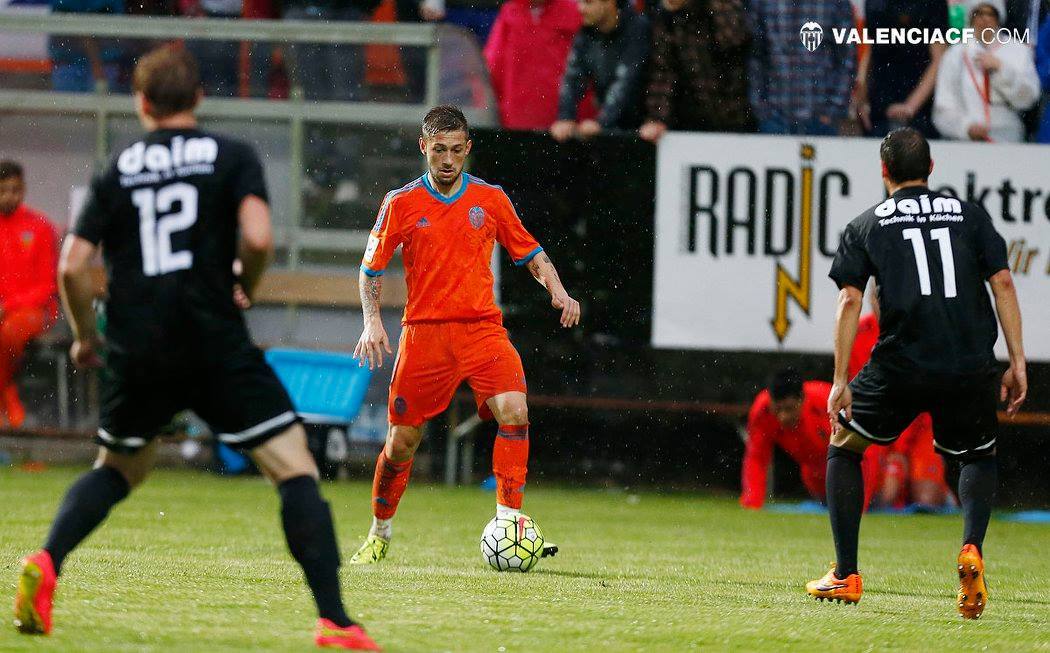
[{"x1": 550, "y1": 0, "x2": 649, "y2": 141}]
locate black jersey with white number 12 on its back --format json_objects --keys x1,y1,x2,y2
[{"x1": 74, "y1": 129, "x2": 267, "y2": 356}]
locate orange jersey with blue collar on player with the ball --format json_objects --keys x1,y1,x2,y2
[{"x1": 361, "y1": 172, "x2": 543, "y2": 324}]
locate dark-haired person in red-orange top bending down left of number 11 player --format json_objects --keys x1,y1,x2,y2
[{"x1": 740, "y1": 367, "x2": 878, "y2": 510}]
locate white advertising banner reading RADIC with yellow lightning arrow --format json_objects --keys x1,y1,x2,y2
[{"x1": 653, "y1": 133, "x2": 1050, "y2": 360}]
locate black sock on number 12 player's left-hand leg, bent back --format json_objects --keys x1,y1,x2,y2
[{"x1": 44, "y1": 467, "x2": 131, "y2": 573}]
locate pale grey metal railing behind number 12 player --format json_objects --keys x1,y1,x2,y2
[{"x1": 0, "y1": 14, "x2": 496, "y2": 269}]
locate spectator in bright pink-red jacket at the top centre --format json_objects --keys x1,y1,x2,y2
[{"x1": 485, "y1": 0, "x2": 580, "y2": 130}]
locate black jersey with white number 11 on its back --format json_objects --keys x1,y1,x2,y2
[{"x1": 830, "y1": 187, "x2": 1007, "y2": 375}]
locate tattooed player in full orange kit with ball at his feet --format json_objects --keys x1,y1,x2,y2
[{"x1": 350, "y1": 105, "x2": 583, "y2": 564}]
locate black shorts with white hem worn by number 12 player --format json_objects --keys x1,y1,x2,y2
[{"x1": 95, "y1": 340, "x2": 298, "y2": 454}]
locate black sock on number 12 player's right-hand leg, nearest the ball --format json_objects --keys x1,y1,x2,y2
[{"x1": 277, "y1": 476, "x2": 354, "y2": 628}]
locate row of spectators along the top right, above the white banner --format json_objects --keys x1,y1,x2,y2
[{"x1": 495, "y1": 0, "x2": 1050, "y2": 143}]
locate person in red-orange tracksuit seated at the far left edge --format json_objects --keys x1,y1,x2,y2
[{"x1": 0, "y1": 161, "x2": 58, "y2": 428}]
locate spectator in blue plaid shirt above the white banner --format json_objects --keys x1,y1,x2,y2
[{"x1": 750, "y1": 0, "x2": 857, "y2": 135}]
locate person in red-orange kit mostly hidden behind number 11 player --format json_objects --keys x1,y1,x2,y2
[{"x1": 849, "y1": 288, "x2": 953, "y2": 508}]
